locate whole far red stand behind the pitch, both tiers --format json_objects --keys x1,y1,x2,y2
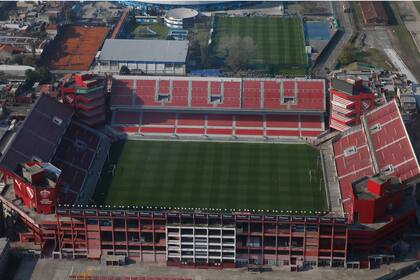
[{"x1": 111, "y1": 76, "x2": 325, "y2": 137}]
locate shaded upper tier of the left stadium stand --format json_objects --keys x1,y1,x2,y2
[{"x1": 0, "y1": 95, "x2": 74, "y2": 170}]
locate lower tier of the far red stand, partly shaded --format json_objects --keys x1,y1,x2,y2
[{"x1": 112, "y1": 110, "x2": 324, "y2": 137}]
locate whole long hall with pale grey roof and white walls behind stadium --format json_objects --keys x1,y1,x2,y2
[{"x1": 97, "y1": 39, "x2": 188, "y2": 75}]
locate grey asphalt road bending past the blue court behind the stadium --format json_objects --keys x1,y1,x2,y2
[{"x1": 312, "y1": 1, "x2": 354, "y2": 77}]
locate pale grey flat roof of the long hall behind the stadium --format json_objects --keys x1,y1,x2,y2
[{"x1": 99, "y1": 39, "x2": 188, "y2": 63}]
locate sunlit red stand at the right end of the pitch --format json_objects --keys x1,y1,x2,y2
[{"x1": 333, "y1": 100, "x2": 420, "y2": 219}]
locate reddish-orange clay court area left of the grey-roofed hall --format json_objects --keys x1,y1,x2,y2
[{"x1": 47, "y1": 25, "x2": 109, "y2": 71}]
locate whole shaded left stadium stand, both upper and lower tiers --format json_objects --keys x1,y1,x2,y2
[{"x1": 0, "y1": 95, "x2": 110, "y2": 203}]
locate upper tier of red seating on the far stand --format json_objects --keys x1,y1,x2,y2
[{"x1": 111, "y1": 77, "x2": 325, "y2": 112}]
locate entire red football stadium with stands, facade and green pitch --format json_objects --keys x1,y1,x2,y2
[{"x1": 0, "y1": 76, "x2": 420, "y2": 271}]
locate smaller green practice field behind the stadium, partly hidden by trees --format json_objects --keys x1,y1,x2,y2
[{"x1": 215, "y1": 16, "x2": 307, "y2": 74}]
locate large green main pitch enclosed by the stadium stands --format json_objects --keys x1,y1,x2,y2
[{"x1": 95, "y1": 141, "x2": 327, "y2": 211}]
